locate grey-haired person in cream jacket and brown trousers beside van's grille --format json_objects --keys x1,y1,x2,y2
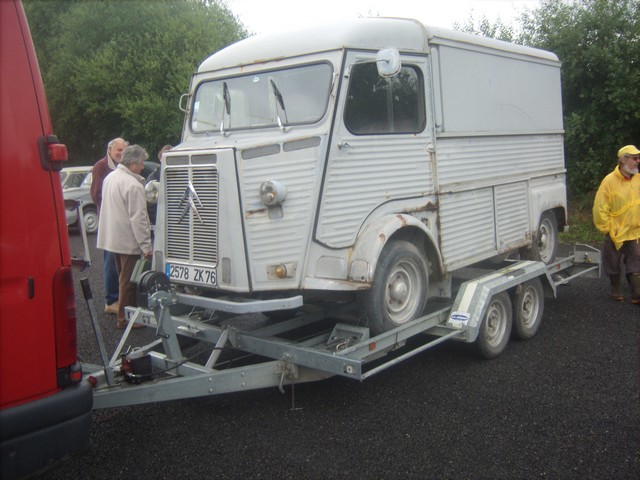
[{"x1": 98, "y1": 145, "x2": 152, "y2": 328}]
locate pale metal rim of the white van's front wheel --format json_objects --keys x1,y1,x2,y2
[{"x1": 385, "y1": 261, "x2": 424, "y2": 324}]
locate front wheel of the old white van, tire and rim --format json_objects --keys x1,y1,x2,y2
[{"x1": 360, "y1": 240, "x2": 429, "y2": 335}]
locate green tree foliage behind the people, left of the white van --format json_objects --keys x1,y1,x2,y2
[{"x1": 24, "y1": 0, "x2": 247, "y2": 164}]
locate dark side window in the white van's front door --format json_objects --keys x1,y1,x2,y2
[{"x1": 344, "y1": 62, "x2": 426, "y2": 135}]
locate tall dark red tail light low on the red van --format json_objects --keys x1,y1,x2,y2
[{"x1": 53, "y1": 267, "x2": 78, "y2": 387}]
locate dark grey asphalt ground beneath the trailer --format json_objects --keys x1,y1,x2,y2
[{"x1": 41, "y1": 231, "x2": 640, "y2": 480}]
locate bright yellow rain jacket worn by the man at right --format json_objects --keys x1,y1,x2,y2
[{"x1": 593, "y1": 166, "x2": 640, "y2": 250}]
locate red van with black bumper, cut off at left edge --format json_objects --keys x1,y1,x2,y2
[{"x1": 0, "y1": 0, "x2": 93, "y2": 479}]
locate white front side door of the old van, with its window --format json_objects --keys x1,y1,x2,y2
[{"x1": 315, "y1": 51, "x2": 434, "y2": 248}]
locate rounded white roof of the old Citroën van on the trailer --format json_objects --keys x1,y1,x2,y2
[{"x1": 198, "y1": 17, "x2": 558, "y2": 72}]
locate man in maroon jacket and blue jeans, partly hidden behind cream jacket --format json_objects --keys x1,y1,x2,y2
[{"x1": 91, "y1": 138, "x2": 127, "y2": 314}]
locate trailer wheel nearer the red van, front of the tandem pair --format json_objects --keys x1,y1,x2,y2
[{"x1": 476, "y1": 292, "x2": 513, "y2": 358}]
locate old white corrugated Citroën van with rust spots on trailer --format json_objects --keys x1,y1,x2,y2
[{"x1": 154, "y1": 18, "x2": 566, "y2": 333}]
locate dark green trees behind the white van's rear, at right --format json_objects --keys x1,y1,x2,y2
[{"x1": 462, "y1": 0, "x2": 640, "y2": 195}]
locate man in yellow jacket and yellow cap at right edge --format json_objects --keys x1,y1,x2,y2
[{"x1": 593, "y1": 145, "x2": 640, "y2": 304}]
